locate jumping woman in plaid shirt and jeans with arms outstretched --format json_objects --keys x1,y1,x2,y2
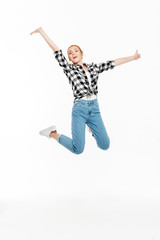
[{"x1": 30, "y1": 27, "x2": 141, "y2": 154}]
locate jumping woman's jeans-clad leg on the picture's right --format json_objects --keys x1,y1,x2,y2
[{"x1": 87, "y1": 103, "x2": 110, "y2": 150}]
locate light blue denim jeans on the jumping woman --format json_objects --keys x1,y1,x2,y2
[{"x1": 57, "y1": 99, "x2": 110, "y2": 154}]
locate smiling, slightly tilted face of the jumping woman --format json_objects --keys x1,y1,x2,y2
[{"x1": 68, "y1": 46, "x2": 83, "y2": 64}]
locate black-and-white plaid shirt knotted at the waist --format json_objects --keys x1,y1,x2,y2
[{"x1": 53, "y1": 49, "x2": 115, "y2": 101}]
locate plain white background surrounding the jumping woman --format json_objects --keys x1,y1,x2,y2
[{"x1": 0, "y1": 0, "x2": 160, "y2": 240}]
